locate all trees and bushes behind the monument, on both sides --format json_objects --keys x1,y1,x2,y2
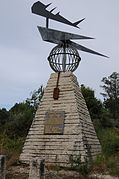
[{"x1": 0, "y1": 72, "x2": 119, "y2": 175}]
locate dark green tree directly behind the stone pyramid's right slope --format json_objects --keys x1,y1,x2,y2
[{"x1": 81, "y1": 85, "x2": 114, "y2": 130}]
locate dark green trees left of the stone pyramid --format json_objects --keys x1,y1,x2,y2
[{"x1": 0, "y1": 86, "x2": 43, "y2": 138}]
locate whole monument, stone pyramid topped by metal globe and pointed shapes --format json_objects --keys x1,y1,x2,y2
[{"x1": 20, "y1": 1, "x2": 107, "y2": 166}]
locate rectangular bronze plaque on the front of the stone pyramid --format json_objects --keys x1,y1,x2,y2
[{"x1": 44, "y1": 111, "x2": 65, "y2": 134}]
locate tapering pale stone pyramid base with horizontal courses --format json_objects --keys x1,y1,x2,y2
[{"x1": 20, "y1": 72, "x2": 101, "y2": 166}]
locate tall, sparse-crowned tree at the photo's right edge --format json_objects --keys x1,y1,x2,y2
[{"x1": 101, "y1": 72, "x2": 119, "y2": 119}]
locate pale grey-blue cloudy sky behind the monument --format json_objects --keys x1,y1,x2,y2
[{"x1": 0, "y1": 0, "x2": 119, "y2": 109}]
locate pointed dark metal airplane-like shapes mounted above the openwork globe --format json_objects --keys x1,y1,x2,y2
[{"x1": 32, "y1": 1, "x2": 109, "y2": 58}]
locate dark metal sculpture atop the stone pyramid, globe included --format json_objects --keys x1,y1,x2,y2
[{"x1": 32, "y1": 1, "x2": 108, "y2": 72}]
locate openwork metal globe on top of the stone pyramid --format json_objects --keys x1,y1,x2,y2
[{"x1": 48, "y1": 43, "x2": 81, "y2": 72}]
